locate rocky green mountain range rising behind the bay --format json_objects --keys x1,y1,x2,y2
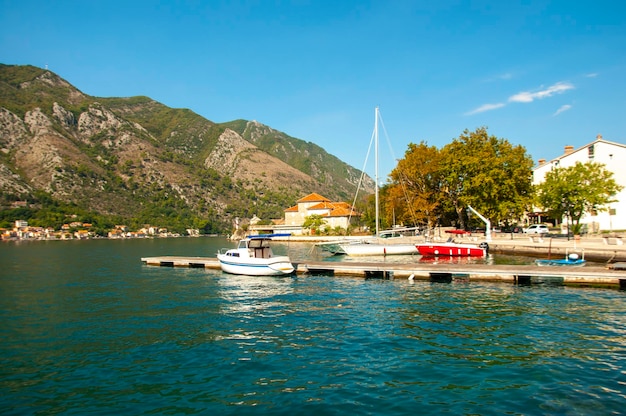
[{"x1": 0, "y1": 64, "x2": 374, "y2": 232}]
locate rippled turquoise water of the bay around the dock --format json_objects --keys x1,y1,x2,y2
[{"x1": 0, "y1": 238, "x2": 626, "y2": 415}]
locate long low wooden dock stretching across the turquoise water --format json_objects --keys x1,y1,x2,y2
[{"x1": 141, "y1": 256, "x2": 626, "y2": 290}]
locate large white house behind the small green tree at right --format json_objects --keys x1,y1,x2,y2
[{"x1": 533, "y1": 135, "x2": 626, "y2": 232}]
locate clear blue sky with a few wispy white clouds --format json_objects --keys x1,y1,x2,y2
[{"x1": 0, "y1": 0, "x2": 626, "y2": 180}]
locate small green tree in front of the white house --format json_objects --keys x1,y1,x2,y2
[{"x1": 537, "y1": 162, "x2": 623, "y2": 234}]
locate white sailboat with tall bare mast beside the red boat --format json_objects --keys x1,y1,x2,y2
[{"x1": 337, "y1": 107, "x2": 418, "y2": 256}]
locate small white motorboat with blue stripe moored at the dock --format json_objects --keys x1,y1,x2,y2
[{"x1": 217, "y1": 234, "x2": 295, "y2": 276}]
